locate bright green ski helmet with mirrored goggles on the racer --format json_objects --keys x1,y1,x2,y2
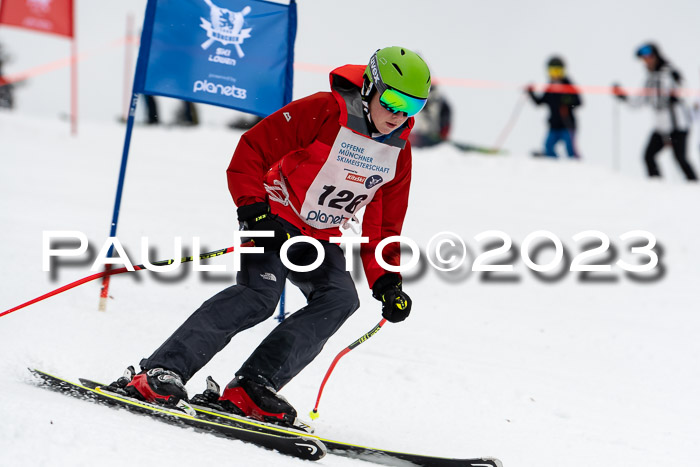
[{"x1": 362, "y1": 47, "x2": 430, "y2": 117}]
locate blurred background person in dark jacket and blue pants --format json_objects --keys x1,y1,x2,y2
[{"x1": 526, "y1": 57, "x2": 582, "y2": 158}]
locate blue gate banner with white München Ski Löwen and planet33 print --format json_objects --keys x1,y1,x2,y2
[{"x1": 134, "y1": 0, "x2": 297, "y2": 116}]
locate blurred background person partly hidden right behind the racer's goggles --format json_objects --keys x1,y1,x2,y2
[{"x1": 409, "y1": 83, "x2": 452, "y2": 148}]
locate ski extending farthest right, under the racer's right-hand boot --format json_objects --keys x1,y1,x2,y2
[{"x1": 80, "y1": 378, "x2": 502, "y2": 467}]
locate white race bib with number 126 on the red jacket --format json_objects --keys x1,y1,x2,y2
[{"x1": 299, "y1": 127, "x2": 401, "y2": 229}]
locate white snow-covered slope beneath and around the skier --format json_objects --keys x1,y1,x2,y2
[{"x1": 0, "y1": 113, "x2": 700, "y2": 467}]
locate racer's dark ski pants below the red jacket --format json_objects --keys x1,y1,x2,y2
[{"x1": 141, "y1": 222, "x2": 359, "y2": 390}]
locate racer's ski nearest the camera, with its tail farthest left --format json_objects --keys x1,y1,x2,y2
[{"x1": 29, "y1": 368, "x2": 327, "y2": 460}]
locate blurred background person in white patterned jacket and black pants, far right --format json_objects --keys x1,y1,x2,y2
[{"x1": 613, "y1": 43, "x2": 697, "y2": 180}]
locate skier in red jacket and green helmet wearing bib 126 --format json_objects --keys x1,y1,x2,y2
[{"x1": 110, "y1": 47, "x2": 430, "y2": 425}]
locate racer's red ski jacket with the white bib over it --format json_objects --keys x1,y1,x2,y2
[{"x1": 226, "y1": 65, "x2": 413, "y2": 287}]
